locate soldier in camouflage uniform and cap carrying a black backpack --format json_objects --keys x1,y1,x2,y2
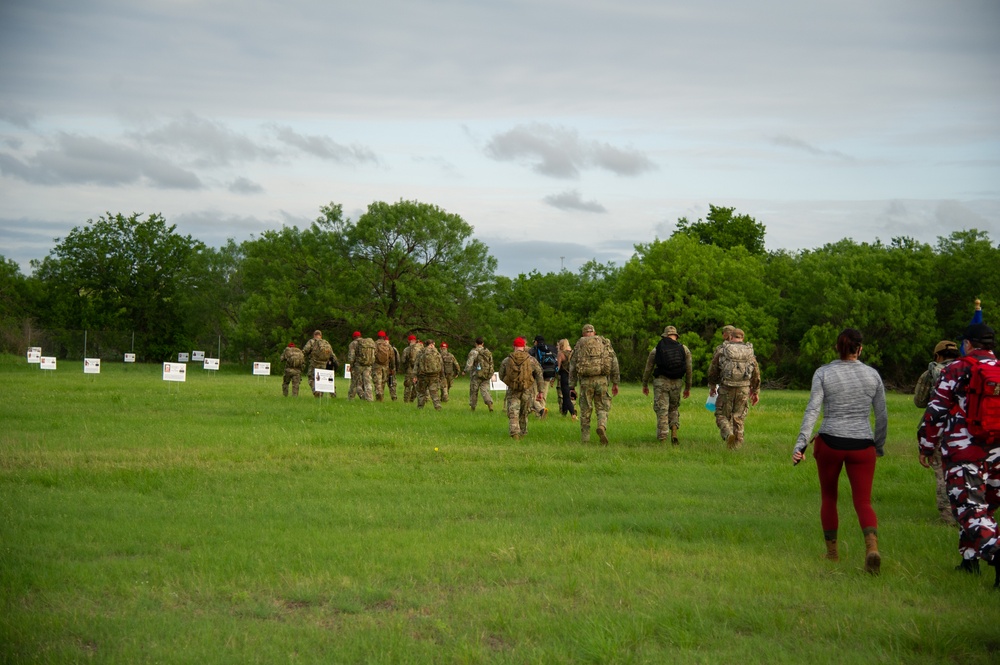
[{"x1": 642, "y1": 326, "x2": 691, "y2": 446}]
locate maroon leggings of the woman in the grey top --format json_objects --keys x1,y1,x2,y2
[{"x1": 813, "y1": 436, "x2": 878, "y2": 531}]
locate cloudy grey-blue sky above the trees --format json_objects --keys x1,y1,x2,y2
[{"x1": 0, "y1": 0, "x2": 1000, "y2": 275}]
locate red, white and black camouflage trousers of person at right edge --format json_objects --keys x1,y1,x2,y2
[{"x1": 944, "y1": 446, "x2": 1000, "y2": 560}]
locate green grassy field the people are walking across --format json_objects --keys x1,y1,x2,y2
[{"x1": 0, "y1": 356, "x2": 1000, "y2": 663}]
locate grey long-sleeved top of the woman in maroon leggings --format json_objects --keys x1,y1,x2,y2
[{"x1": 795, "y1": 360, "x2": 889, "y2": 457}]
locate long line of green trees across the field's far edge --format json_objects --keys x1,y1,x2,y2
[{"x1": 0, "y1": 200, "x2": 1000, "y2": 389}]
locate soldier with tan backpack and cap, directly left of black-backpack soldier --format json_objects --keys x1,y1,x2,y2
[{"x1": 569, "y1": 323, "x2": 621, "y2": 446}]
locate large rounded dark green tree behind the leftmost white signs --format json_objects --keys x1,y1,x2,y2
[{"x1": 32, "y1": 213, "x2": 205, "y2": 358}]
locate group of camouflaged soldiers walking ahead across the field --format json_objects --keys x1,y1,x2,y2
[{"x1": 281, "y1": 323, "x2": 760, "y2": 449}]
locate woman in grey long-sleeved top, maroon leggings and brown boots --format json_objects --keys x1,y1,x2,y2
[{"x1": 792, "y1": 328, "x2": 888, "y2": 575}]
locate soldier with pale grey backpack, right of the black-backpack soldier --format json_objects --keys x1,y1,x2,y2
[{"x1": 708, "y1": 328, "x2": 760, "y2": 450}]
